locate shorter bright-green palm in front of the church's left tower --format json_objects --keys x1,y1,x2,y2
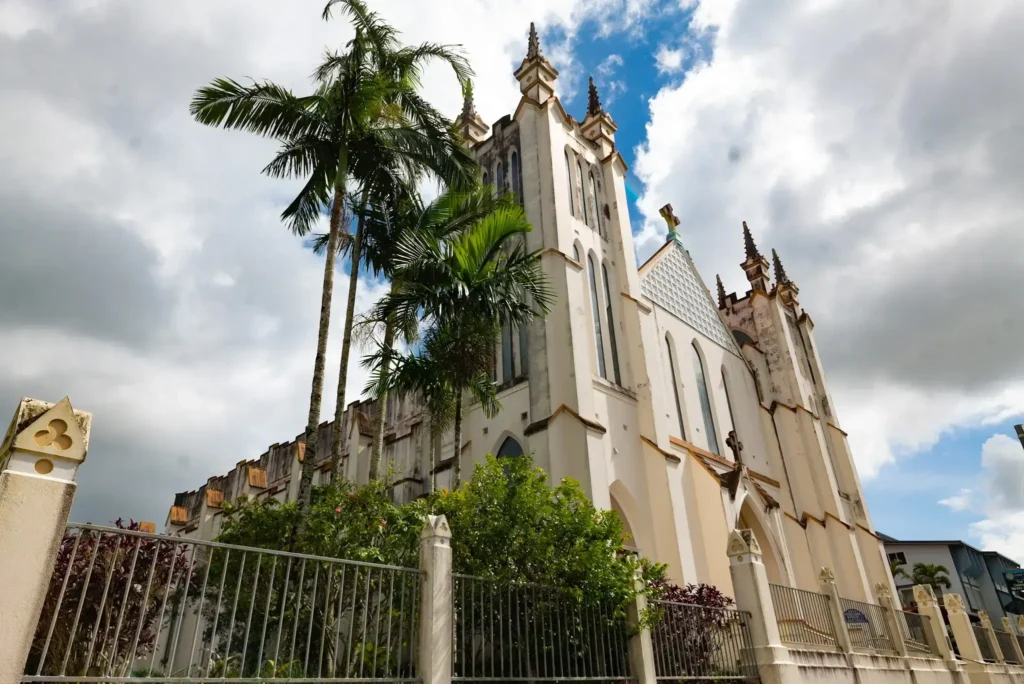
[{"x1": 370, "y1": 188, "x2": 552, "y2": 486}]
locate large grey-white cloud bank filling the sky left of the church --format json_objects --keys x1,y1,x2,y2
[{"x1": 0, "y1": 0, "x2": 655, "y2": 522}]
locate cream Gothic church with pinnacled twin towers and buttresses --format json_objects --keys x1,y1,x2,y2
[{"x1": 168, "y1": 28, "x2": 890, "y2": 600}]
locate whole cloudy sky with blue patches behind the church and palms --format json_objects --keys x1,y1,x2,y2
[{"x1": 0, "y1": 0, "x2": 1024, "y2": 562}]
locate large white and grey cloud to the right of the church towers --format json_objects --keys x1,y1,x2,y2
[{"x1": 634, "y1": 0, "x2": 1024, "y2": 477}]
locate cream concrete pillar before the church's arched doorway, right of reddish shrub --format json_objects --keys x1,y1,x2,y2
[{"x1": 727, "y1": 529, "x2": 801, "y2": 684}]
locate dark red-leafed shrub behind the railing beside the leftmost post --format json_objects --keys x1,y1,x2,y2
[{"x1": 26, "y1": 518, "x2": 200, "y2": 677}]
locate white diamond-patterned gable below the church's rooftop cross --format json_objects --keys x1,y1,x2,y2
[{"x1": 640, "y1": 243, "x2": 736, "y2": 353}]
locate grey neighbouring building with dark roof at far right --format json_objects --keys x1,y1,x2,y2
[{"x1": 880, "y1": 535, "x2": 1024, "y2": 622}]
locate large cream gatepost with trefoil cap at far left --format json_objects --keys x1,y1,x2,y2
[{"x1": 0, "y1": 397, "x2": 92, "y2": 684}]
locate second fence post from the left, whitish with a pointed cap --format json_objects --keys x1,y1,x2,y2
[{"x1": 418, "y1": 515, "x2": 453, "y2": 684}]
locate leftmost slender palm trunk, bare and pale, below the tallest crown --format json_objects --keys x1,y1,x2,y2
[{"x1": 291, "y1": 179, "x2": 345, "y2": 532}]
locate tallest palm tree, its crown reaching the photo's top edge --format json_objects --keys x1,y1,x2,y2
[{"x1": 189, "y1": 0, "x2": 475, "y2": 524}]
